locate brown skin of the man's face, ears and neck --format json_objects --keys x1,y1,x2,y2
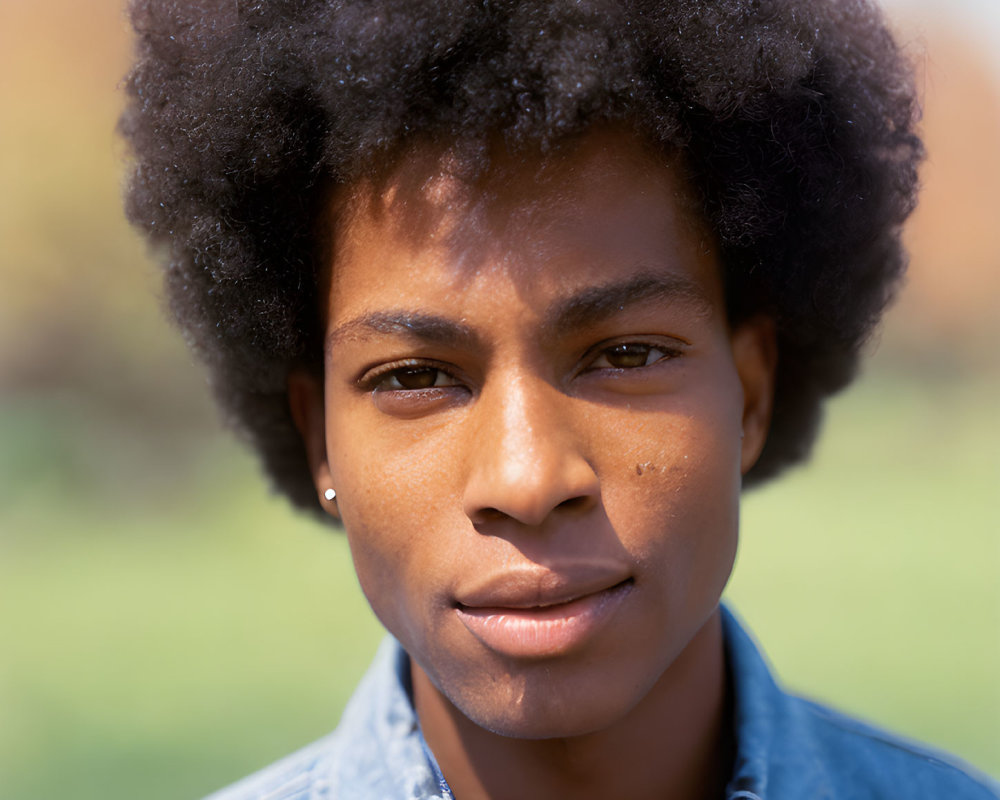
[{"x1": 289, "y1": 130, "x2": 775, "y2": 800}]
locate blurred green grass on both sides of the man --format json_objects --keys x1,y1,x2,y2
[{"x1": 0, "y1": 366, "x2": 1000, "y2": 800}]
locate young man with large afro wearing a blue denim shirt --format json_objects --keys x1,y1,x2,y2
[{"x1": 123, "y1": 0, "x2": 997, "y2": 800}]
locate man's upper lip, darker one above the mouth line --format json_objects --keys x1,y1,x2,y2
[{"x1": 455, "y1": 562, "x2": 631, "y2": 609}]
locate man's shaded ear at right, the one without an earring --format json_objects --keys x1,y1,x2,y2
[{"x1": 731, "y1": 315, "x2": 778, "y2": 475}]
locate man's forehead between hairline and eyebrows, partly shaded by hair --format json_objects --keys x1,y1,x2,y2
[{"x1": 330, "y1": 129, "x2": 721, "y2": 316}]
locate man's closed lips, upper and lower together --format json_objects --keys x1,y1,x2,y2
[{"x1": 455, "y1": 565, "x2": 633, "y2": 658}]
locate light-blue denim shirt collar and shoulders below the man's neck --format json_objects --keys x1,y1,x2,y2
[{"x1": 206, "y1": 608, "x2": 1000, "y2": 800}]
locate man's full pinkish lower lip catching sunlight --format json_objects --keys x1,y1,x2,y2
[{"x1": 456, "y1": 581, "x2": 632, "y2": 658}]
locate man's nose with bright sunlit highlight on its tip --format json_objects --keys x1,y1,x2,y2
[{"x1": 464, "y1": 376, "x2": 600, "y2": 526}]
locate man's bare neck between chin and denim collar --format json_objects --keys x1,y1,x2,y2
[{"x1": 412, "y1": 611, "x2": 732, "y2": 800}]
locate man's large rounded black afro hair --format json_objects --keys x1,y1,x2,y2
[{"x1": 120, "y1": 0, "x2": 923, "y2": 509}]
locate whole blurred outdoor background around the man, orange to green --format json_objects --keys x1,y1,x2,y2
[{"x1": 0, "y1": 0, "x2": 1000, "y2": 800}]
